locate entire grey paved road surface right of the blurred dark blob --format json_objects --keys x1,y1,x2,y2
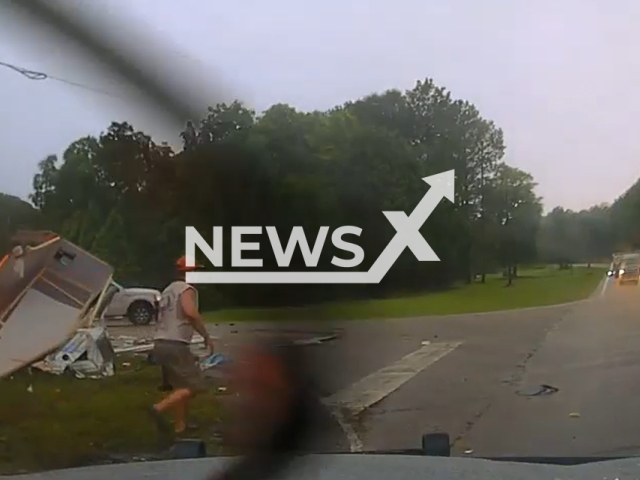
[{"x1": 109, "y1": 274, "x2": 640, "y2": 456}]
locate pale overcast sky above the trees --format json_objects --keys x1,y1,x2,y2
[{"x1": 0, "y1": 0, "x2": 640, "y2": 210}]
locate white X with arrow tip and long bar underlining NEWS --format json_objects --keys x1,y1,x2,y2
[{"x1": 186, "y1": 170, "x2": 455, "y2": 284}]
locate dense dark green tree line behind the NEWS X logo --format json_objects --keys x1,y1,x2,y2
[{"x1": 0, "y1": 79, "x2": 624, "y2": 307}]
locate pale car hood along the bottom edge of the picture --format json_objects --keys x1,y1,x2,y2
[{"x1": 6, "y1": 454, "x2": 640, "y2": 480}]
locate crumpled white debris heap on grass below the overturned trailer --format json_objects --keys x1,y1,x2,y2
[{"x1": 32, "y1": 327, "x2": 115, "y2": 378}]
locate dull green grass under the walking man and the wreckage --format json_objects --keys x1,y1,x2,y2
[{"x1": 0, "y1": 357, "x2": 221, "y2": 475}]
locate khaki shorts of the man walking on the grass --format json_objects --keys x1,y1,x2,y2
[{"x1": 152, "y1": 340, "x2": 205, "y2": 393}]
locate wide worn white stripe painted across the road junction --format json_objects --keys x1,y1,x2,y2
[{"x1": 322, "y1": 342, "x2": 462, "y2": 452}]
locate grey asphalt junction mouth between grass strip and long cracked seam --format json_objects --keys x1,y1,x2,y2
[{"x1": 304, "y1": 306, "x2": 592, "y2": 452}]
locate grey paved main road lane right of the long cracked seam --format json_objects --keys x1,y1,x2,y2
[{"x1": 466, "y1": 274, "x2": 640, "y2": 456}]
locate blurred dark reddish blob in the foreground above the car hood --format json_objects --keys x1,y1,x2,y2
[{"x1": 213, "y1": 338, "x2": 318, "y2": 479}]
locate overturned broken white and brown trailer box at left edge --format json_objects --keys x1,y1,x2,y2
[{"x1": 0, "y1": 232, "x2": 113, "y2": 378}]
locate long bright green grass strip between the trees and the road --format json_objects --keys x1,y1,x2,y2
[{"x1": 205, "y1": 266, "x2": 605, "y2": 322}]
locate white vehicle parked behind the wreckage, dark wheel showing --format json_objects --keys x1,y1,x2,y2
[{"x1": 104, "y1": 282, "x2": 161, "y2": 325}]
